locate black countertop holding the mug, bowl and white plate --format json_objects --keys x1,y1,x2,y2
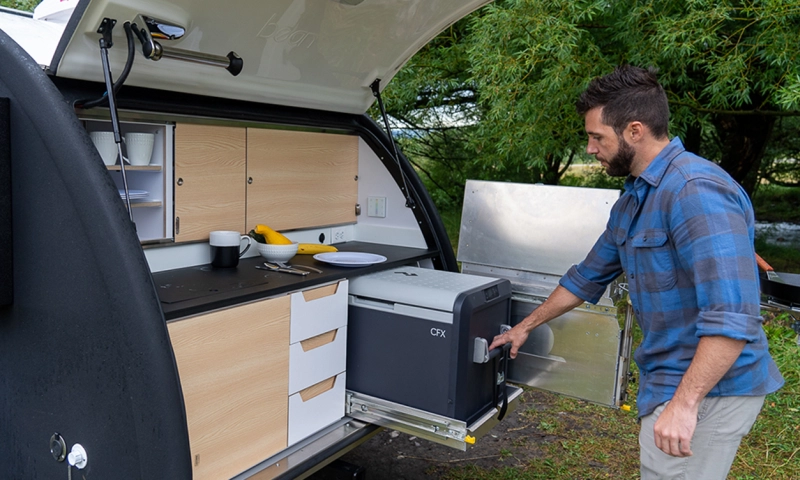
[{"x1": 153, "y1": 242, "x2": 439, "y2": 320}]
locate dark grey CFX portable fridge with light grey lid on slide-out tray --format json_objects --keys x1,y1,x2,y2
[{"x1": 347, "y1": 267, "x2": 511, "y2": 423}]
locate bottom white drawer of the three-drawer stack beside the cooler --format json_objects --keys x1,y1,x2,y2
[{"x1": 289, "y1": 372, "x2": 346, "y2": 445}]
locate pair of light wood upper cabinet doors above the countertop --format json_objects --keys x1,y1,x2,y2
[{"x1": 174, "y1": 124, "x2": 358, "y2": 242}]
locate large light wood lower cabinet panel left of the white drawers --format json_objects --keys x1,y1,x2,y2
[{"x1": 168, "y1": 296, "x2": 291, "y2": 479}]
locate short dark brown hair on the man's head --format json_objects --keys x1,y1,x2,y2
[{"x1": 575, "y1": 65, "x2": 669, "y2": 138}]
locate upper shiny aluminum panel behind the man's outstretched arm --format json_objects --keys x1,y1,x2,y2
[{"x1": 458, "y1": 180, "x2": 619, "y2": 275}]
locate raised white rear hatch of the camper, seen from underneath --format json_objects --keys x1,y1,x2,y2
[{"x1": 18, "y1": 0, "x2": 490, "y2": 114}]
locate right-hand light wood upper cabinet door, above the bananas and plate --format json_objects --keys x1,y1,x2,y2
[{"x1": 247, "y1": 128, "x2": 358, "y2": 230}]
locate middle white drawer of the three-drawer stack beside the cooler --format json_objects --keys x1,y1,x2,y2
[{"x1": 289, "y1": 327, "x2": 347, "y2": 395}]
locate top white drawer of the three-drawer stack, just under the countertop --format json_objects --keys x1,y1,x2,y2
[{"x1": 289, "y1": 280, "x2": 347, "y2": 343}]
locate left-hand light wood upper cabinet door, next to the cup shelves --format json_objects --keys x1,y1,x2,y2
[{"x1": 175, "y1": 124, "x2": 247, "y2": 242}]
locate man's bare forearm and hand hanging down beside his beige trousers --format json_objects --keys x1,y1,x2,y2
[{"x1": 653, "y1": 336, "x2": 745, "y2": 457}]
